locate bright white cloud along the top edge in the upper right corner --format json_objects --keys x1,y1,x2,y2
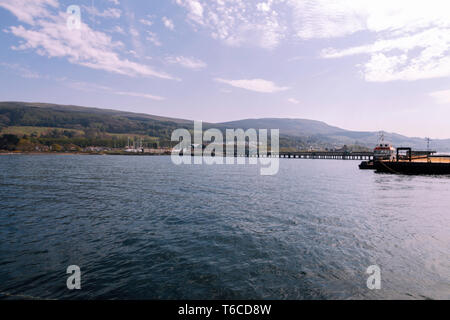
[{"x1": 287, "y1": 0, "x2": 449, "y2": 39}]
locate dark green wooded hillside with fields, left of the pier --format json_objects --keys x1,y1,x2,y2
[{"x1": 0, "y1": 102, "x2": 192, "y2": 147}]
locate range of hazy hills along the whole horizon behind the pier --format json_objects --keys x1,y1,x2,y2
[{"x1": 0, "y1": 102, "x2": 450, "y2": 152}]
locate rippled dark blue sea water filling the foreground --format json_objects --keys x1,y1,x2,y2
[{"x1": 0, "y1": 155, "x2": 450, "y2": 299}]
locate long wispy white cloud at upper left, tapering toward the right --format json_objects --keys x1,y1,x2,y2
[{"x1": 0, "y1": 0, "x2": 175, "y2": 79}]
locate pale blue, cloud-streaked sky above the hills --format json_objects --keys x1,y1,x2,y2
[{"x1": 0, "y1": 0, "x2": 450, "y2": 138}]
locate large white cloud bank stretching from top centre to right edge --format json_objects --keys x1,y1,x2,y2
[{"x1": 176, "y1": 0, "x2": 450, "y2": 81}]
